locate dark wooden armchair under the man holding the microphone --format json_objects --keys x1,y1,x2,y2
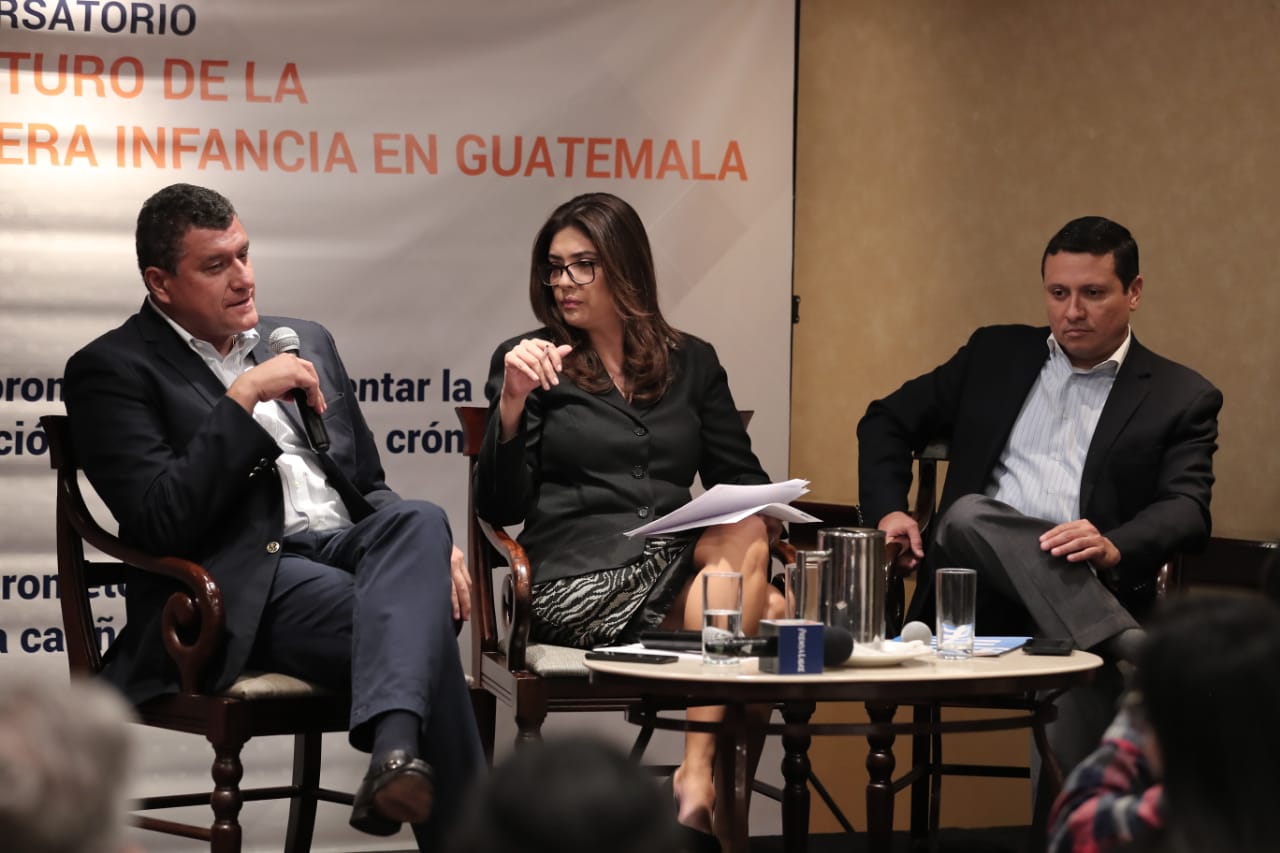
[{"x1": 40, "y1": 415, "x2": 352, "y2": 853}]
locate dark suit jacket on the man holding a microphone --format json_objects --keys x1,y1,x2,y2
[{"x1": 64, "y1": 302, "x2": 399, "y2": 702}]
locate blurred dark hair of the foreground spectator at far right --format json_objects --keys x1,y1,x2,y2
[{"x1": 1134, "y1": 593, "x2": 1280, "y2": 850}]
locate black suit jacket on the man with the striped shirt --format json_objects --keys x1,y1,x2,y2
[{"x1": 858, "y1": 325, "x2": 1222, "y2": 611}]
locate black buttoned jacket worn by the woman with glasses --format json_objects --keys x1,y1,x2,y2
[{"x1": 476, "y1": 329, "x2": 769, "y2": 581}]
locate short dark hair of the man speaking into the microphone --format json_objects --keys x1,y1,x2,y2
[{"x1": 134, "y1": 183, "x2": 236, "y2": 274}]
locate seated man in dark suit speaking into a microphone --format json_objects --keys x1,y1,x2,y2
[{"x1": 65, "y1": 184, "x2": 484, "y2": 849}]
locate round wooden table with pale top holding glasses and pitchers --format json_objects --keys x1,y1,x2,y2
[{"x1": 586, "y1": 651, "x2": 1102, "y2": 853}]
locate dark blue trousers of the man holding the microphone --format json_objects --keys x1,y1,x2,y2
[{"x1": 250, "y1": 501, "x2": 485, "y2": 850}]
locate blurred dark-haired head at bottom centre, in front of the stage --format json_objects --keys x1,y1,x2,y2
[{"x1": 449, "y1": 736, "x2": 682, "y2": 853}]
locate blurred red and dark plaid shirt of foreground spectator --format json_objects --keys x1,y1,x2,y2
[{"x1": 1048, "y1": 708, "x2": 1164, "y2": 853}]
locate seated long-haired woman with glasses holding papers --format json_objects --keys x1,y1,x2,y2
[{"x1": 476, "y1": 193, "x2": 785, "y2": 836}]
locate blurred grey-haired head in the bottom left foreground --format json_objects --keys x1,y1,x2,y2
[{"x1": 0, "y1": 679, "x2": 133, "y2": 853}]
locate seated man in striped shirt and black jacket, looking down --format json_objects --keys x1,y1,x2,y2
[{"x1": 858, "y1": 216, "x2": 1222, "y2": 819}]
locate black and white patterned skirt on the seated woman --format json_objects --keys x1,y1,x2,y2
[{"x1": 530, "y1": 532, "x2": 698, "y2": 648}]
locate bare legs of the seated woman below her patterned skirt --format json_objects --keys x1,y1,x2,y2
[{"x1": 663, "y1": 516, "x2": 786, "y2": 843}]
